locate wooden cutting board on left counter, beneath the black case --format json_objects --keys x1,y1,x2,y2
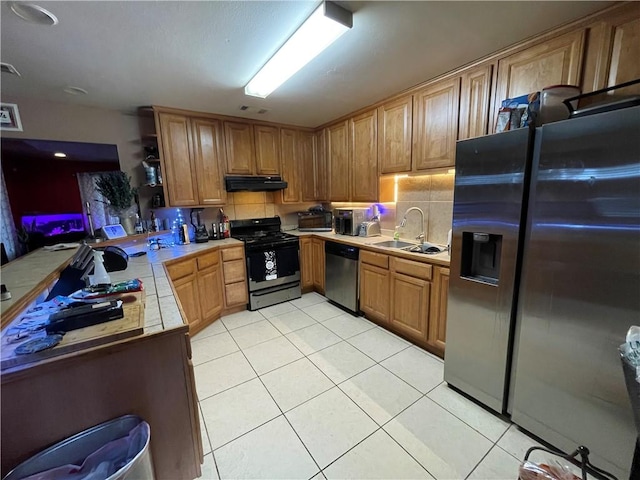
[{"x1": 0, "y1": 291, "x2": 145, "y2": 370}]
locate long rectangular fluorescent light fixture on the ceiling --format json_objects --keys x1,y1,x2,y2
[{"x1": 244, "y1": 1, "x2": 353, "y2": 98}]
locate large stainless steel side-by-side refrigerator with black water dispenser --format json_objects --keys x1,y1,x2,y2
[{"x1": 444, "y1": 102, "x2": 640, "y2": 478}]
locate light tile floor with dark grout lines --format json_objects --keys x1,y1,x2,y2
[{"x1": 192, "y1": 293, "x2": 536, "y2": 480}]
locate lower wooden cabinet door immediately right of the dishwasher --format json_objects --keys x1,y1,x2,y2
[{"x1": 360, "y1": 263, "x2": 389, "y2": 325}]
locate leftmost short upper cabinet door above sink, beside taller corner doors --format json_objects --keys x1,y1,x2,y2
[{"x1": 378, "y1": 96, "x2": 413, "y2": 173}]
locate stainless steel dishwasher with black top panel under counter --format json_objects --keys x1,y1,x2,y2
[{"x1": 324, "y1": 242, "x2": 360, "y2": 315}]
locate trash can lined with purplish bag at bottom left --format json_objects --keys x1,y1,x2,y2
[{"x1": 3, "y1": 415, "x2": 155, "y2": 480}]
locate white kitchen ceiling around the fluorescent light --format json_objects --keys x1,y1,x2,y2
[{"x1": 0, "y1": 0, "x2": 609, "y2": 127}]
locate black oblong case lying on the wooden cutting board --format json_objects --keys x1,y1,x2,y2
[{"x1": 45, "y1": 300, "x2": 124, "y2": 333}]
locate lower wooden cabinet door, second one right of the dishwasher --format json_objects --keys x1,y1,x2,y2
[{"x1": 390, "y1": 272, "x2": 430, "y2": 344}]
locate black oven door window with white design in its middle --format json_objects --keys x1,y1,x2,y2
[{"x1": 247, "y1": 245, "x2": 300, "y2": 283}]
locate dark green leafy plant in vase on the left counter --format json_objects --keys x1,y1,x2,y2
[{"x1": 96, "y1": 171, "x2": 137, "y2": 235}]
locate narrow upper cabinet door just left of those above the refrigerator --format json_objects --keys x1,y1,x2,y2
[{"x1": 458, "y1": 65, "x2": 493, "y2": 140}]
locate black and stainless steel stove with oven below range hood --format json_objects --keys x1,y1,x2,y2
[{"x1": 231, "y1": 217, "x2": 302, "y2": 310}]
